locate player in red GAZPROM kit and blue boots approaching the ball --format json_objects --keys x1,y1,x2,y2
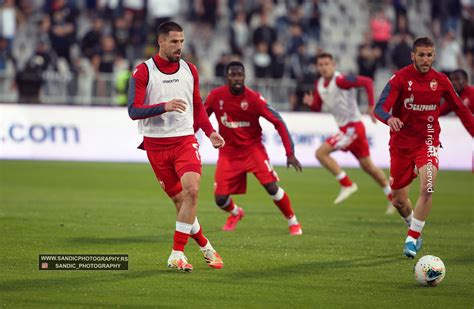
[{"x1": 375, "y1": 37, "x2": 474, "y2": 258}]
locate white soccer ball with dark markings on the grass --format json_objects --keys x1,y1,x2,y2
[{"x1": 414, "y1": 255, "x2": 446, "y2": 286}]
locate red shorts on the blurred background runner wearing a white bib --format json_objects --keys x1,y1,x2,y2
[{"x1": 326, "y1": 121, "x2": 370, "y2": 158}]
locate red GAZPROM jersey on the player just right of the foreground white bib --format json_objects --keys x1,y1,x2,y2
[{"x1": 205, "y1": 85, "x2": 294, "y2": 156}]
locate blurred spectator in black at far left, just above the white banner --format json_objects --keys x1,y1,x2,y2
[{"x1": 15, "y1": 57, "x2": 44, "y2": 103}]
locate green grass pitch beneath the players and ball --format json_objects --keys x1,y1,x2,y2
[{"x1": 0, "y1": 161, "x2": 474, "y2": 308}]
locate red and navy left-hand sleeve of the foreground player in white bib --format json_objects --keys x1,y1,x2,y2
[{"x1": 128, "y1": 63, "x2": 166, "y2": 120}]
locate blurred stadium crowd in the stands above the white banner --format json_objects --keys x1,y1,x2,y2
[{"x1": 0, "y1": 0, "x2": 474, "y2": 110}]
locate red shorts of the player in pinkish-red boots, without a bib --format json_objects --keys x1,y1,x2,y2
[{"x1": 214, "y1": 145, "x2": 279, "y2": 195}]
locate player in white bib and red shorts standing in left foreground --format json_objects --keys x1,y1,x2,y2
[{"x1": 128, "y1": 22, "x2": 224, "y2": 271}]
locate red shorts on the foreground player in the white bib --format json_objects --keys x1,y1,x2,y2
[{"x1": 146, "y1": 135, "x2": 202, "y2": 197}]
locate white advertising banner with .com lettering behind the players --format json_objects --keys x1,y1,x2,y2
[{"x1": 0, "y1": 104, "x2": 473, "y2": 170}]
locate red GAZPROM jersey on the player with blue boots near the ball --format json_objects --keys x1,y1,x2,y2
[{"x1": 375, "y1": 65, "x2": 474, "y2": 148}]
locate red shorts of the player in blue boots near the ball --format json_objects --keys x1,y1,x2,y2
[{"x1": 390, "y1": 145, "x2": 439, "y2": 190}]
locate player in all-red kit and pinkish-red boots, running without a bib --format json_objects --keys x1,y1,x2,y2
[{"x1": 205, "y1": 61, "x2": 303, "y2": 235}]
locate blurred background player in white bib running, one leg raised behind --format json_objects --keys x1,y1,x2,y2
[{"x1": 303, "y1": 53, "x2": 394, "y2": 213}]
